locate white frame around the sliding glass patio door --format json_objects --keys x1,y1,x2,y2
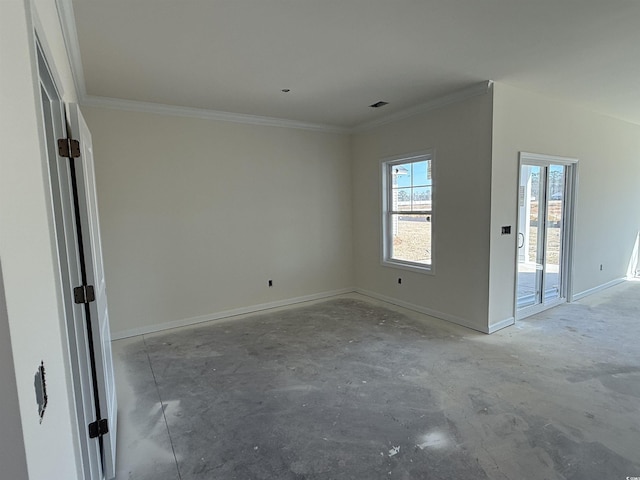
[{"x1": 513, "y1": 151, "x2": 578, "y2": 321}]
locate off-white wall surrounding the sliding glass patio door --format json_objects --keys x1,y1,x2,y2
[{"x1": 490, "y1": 83, "x2": 640, "y2": 324}]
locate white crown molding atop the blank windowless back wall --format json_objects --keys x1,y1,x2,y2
[{"x1": 80, "y1": 95, "x2": 350, "y2": 133}]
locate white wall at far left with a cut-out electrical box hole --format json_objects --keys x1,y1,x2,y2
[{"x1": 0, "y1": 0, "x2": 79, "y2": 480}]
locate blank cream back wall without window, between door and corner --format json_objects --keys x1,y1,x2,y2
[{"x1": 83, "y1": 108, "x2": 353, "y2": 337}]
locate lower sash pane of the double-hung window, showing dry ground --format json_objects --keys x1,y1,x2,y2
[{"x1": 391, "y1": 214, "x2": 431, "y2": 265}]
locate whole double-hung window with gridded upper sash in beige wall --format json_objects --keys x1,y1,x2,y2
[{"x1": 382, "y1": 152, "x2": 434, "y2": 272}]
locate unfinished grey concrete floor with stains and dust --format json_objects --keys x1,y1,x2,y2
[{"x1": 114, "y1": 282, "x2": 640, "y2": 480}]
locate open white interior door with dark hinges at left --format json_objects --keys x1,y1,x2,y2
[{"x1": 67, "y1": 104, "x2": 117, "y2": 479}]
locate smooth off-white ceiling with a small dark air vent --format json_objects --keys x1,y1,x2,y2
[{"x1": 66, "y1": 0, "x2": 640, "y2": 128}]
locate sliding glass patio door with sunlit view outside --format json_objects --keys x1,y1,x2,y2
[{"x1": 515, "y1": 152, "x2": 578, "y2": 319}]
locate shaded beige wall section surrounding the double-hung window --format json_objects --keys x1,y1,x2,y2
[{"x1": 352, "y1": 92, "x2": 492, "y2": 331}]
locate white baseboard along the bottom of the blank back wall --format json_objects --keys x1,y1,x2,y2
[{"x1": 111, "y1": 288, "x2": 356, "y2": 341}]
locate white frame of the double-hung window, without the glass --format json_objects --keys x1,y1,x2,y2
[{"x1": 380, "y1": 149, "x2": 437, "y2": 275}]
